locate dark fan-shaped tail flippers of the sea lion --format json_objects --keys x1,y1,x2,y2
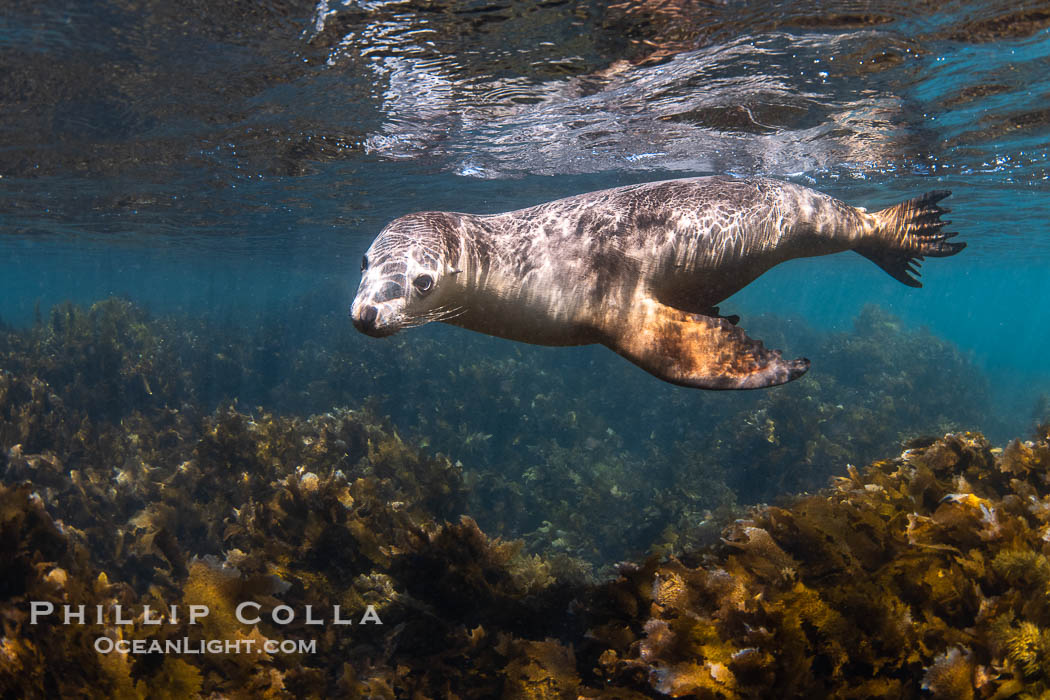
[{"x1": 854, "y1": 190, "x2": 966, "y2": 287}]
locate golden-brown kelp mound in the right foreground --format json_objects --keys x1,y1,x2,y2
[{"x1": 588, "y1": 433, "x2": 1050, "y2": 698}]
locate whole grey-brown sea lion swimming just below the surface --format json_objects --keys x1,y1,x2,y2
[{"x1": 351, "y1": 177, "x2": 965, "y2": 389}]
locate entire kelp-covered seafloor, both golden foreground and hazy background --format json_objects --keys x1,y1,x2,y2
[{"x1": 0, "y1": 299, "x2": 1050, "y2": 698}]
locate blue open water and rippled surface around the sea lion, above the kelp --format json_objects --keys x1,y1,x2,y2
[{"x1": 0, "y1": 0, "x2": 1050, "y2": 442}]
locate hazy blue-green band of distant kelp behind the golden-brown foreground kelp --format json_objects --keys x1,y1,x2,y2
[{"x1": 0, "y1": 291, "x2": 991, "y2": 564}]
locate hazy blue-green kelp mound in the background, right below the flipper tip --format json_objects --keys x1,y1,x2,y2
[{"x1": 707, "y1": 304, "x2": 1000, "y2": 503}]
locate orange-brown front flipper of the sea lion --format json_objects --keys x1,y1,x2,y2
[{"x1": 605, "y1": 299, "x2": 810, "y2": 389}]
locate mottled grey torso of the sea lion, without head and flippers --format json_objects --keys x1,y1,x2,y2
[{"x1": 426, "y1": 177, "x2": 866, "y2": 345}]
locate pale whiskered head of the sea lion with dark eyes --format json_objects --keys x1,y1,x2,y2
[{"x1": 350, "y1": 212, "x2": 459, "y2": 338}]
